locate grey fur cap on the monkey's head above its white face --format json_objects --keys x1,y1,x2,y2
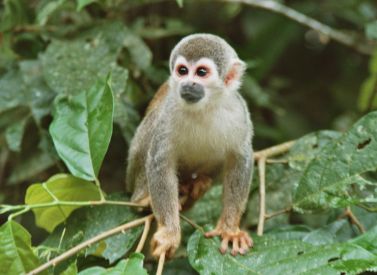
[{"x1": 170, "y1": 35, "x2": 235, "y2": 75}]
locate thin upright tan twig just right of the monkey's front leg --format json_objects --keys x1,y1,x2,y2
[{"x1": 257, "y1": 157, "x2": 266, "y2": 236}]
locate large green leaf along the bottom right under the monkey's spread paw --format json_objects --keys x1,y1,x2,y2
[{"x1": 187, "y1": 227, "x2": 377, "y2": 275}]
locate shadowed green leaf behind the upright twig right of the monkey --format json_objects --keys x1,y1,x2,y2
[{"x1": 244, "y1": 130, "x2": 340, "y2": 230}]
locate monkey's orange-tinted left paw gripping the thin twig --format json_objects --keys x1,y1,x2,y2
[{"x1": 151, "y1": 226, "x2": 181, "y2": 258}]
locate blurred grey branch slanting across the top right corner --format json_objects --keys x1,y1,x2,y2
[{"x1": 222, "y1": 0, "x2": 376, "y2": 55}]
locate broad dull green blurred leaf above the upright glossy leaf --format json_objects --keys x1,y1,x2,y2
[{"x1": 40, "y1": 37, "x2": 128, "y2": 95}]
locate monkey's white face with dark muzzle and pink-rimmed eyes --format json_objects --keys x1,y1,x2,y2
[{"x1": 172, "y1": 56, "x2": 222, "y2": 106}]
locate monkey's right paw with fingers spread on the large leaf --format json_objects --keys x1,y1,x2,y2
[{"x1": 205, "y1": 228, "x2": 253, "y2": 256}]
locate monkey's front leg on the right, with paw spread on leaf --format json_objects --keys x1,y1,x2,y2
[{"x1": 205, "y1": 149, "x2": 253, "y2": 256}]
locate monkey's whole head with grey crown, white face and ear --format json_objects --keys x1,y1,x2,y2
[{"x1": 169, "y1": 34, "x2": 246, "y2": 106}]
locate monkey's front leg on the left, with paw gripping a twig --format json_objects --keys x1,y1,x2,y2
[{"x1": 146, "y1": 138, "x2": 181, "y2": 257}]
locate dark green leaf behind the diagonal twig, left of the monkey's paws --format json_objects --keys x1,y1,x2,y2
[{"x1": 44, "y1": 195, "x2": 143, "y2": 263}]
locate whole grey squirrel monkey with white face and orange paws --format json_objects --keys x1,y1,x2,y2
[{"x1": 126, "y1": 34, "x2": 253, "y2": 257}]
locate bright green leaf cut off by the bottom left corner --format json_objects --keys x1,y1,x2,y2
[{"x1": 0, "y1": 221, "x2": 39, "y2": 274}]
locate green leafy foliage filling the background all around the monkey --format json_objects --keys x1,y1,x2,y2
[{"x1": 0, "y1": 0, "x2": 377, "y2": 275}]
